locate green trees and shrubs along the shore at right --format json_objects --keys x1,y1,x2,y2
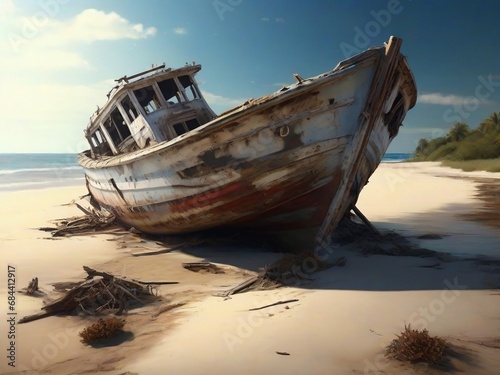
[{"x1": 413, "y1": 112, "x2": 500, "y2": 161}]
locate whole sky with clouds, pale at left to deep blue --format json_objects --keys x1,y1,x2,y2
[{"x1": 0, "y1": 0, "x2": 500, "y2": 153}]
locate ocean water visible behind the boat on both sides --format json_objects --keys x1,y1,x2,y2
[{"x1": 0, "y1": 153, "x2": 411, "y2": 191}]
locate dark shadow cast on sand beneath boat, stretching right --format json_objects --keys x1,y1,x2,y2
[{"x1": 130, "y1": 214, "x2": 500, "y2": 291}]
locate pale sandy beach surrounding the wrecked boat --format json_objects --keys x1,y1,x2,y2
[{"x1": 0, "y1": 163, "x2": 500, "y2": 375}]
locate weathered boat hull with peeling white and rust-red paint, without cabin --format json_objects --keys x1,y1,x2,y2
[{"x1": 79, "y1": 38, "x2": 416, "y2": 250}]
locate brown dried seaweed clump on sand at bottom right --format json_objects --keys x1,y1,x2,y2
[{"x1": 385, "y1": 325, "x2": 446, "y2": 363}]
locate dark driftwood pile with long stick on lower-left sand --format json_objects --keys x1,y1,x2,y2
[{"x1": 19, "y1": 266, "x2": 157, "y2": 323}]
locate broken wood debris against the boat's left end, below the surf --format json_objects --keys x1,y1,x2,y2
[{"x1": 38, "y1": 203, "x2": 116, "y2": 237}]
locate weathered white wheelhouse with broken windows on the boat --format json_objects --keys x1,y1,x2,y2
[{"x1": 85, "y1": 63, "x2": 216, "y2": 158}]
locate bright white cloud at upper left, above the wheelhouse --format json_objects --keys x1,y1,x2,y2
[{"x1": 0, "y1": 8, "x2": 156, "y2": 72}]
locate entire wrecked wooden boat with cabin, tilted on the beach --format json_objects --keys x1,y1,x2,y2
[{"x1": 78, "y1": 37, "x2": 416, "y2": 251}]
